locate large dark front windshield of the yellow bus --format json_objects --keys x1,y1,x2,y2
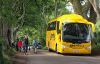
[{"x1": 62, "y1": 23, "x2": 91, "y2": 43}]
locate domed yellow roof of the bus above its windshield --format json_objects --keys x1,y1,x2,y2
[{"x1": 49, "y1": 14, "x2": 88, "y2": 23}]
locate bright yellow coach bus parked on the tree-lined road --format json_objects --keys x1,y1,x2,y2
[{"x1": 46, "y1": 14, "x2": 95, "y2": 54}]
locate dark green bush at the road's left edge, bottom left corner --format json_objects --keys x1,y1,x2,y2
[{"x1": 0, "y1": 37, "x2": 15, "y2": 64}]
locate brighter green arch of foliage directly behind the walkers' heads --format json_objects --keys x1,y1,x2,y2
[{"x1": 17, "y1": 26, "x2": 45, "y2": 46}]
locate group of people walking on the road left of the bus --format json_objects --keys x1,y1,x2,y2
[{"x1": 16, "y1": 35, "x2": 38, "y2": 54}]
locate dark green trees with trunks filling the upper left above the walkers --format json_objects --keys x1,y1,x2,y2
[{"x1": 0, "y1": 0, "x2": 68, "y2": 53}]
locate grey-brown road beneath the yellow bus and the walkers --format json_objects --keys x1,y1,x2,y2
[{"x1": 13, "y1": 50, "x2": 100, "y2": 64}]
